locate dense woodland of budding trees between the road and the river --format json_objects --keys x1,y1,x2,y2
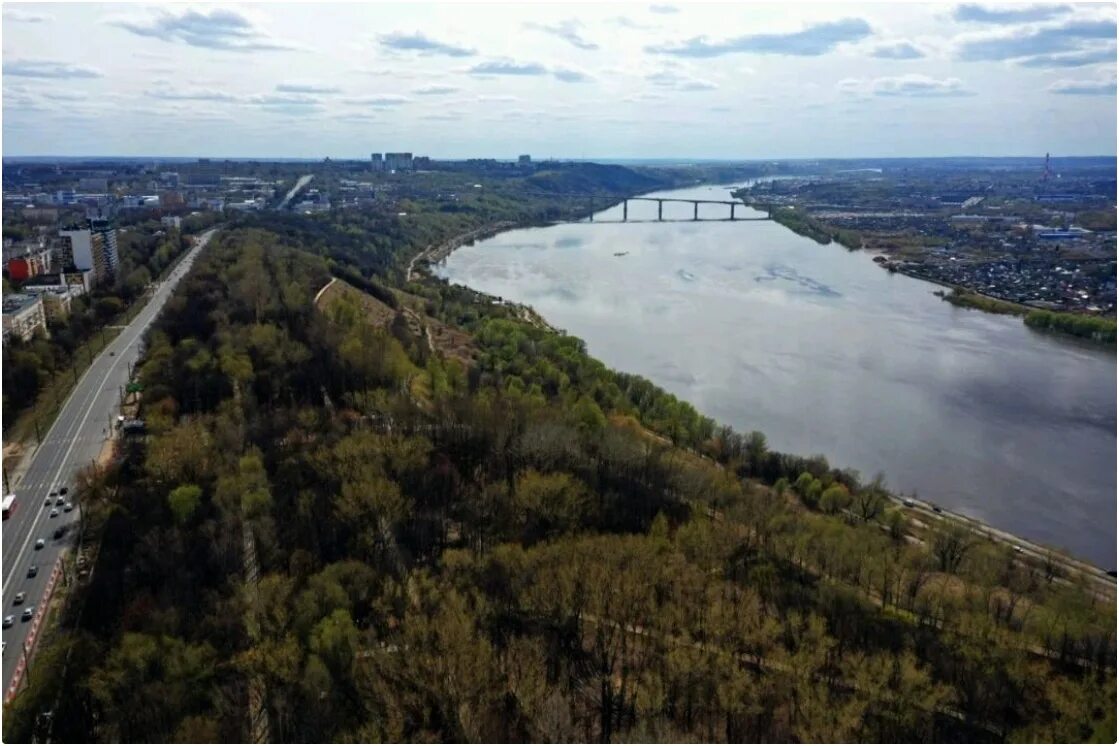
[{"x1": 4, "y1": 171, "x2": 1116, "y2": 743}]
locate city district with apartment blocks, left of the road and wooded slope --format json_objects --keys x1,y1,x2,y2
[{"x1": 3, "y1": 153, "x2": 532, "y2": 343}]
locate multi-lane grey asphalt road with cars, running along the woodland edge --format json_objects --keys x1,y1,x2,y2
[{"x1": 0, "y1": 228, "x2": 216, "y2": 692}]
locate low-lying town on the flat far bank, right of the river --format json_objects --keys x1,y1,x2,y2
[{"x1": 739, "y1": 155, "x2": 1116, "y2": 317}]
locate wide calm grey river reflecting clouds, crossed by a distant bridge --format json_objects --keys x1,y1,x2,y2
[{"x1": 436, "y1": 187, "x2": 1116, "y2": 569}]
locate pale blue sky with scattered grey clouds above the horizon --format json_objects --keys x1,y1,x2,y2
[{"x1": 2, "y1": 2, "x2": 1117, "y2": 159}]
